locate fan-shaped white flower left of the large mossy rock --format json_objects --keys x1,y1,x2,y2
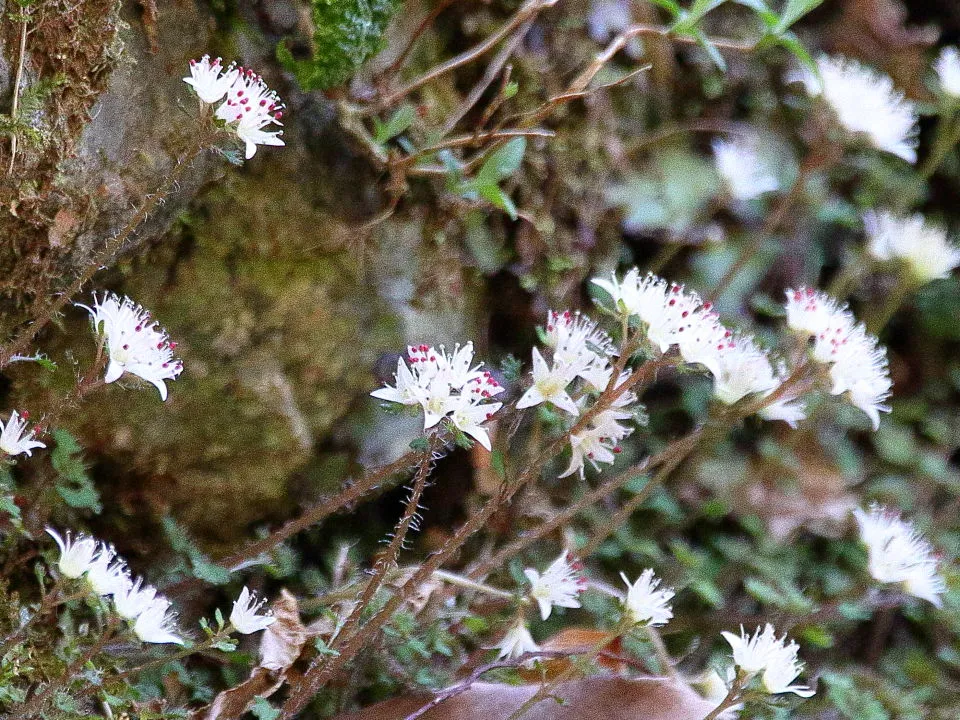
[{"x1": 77, "y1": 293, "x2": 183, "y2": 400}]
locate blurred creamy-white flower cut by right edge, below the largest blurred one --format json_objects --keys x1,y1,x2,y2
[{"x1": 864, "y1": 212, "x2": 960, "y2": 283}]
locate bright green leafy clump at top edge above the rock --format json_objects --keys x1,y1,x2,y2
[{"x1": 277, "y1": 0, "x2": 399, "y2": 91}]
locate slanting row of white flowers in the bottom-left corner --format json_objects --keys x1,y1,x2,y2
[{"x1": 47, "y1": 528, "x2": 184, "y2": 645}]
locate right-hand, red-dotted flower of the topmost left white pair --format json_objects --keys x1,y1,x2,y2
[{"x1": 216, "y1": 68, "x2": 284, "y2": 160}]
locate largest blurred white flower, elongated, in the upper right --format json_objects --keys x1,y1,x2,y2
[{"x1": 799, "y1": 56, "x2": 919, "y2": 163}]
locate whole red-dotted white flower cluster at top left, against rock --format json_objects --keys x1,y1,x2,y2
[{"x1": 183, "y1": 55, "x2": 284, "y2": 160}]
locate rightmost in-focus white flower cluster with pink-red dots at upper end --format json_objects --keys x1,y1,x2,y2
[{"x1": 785, "y1": 287, "x2": 893, "y2": 430}]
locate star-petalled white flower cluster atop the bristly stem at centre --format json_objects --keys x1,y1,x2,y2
[{"x1": 370, "y1": 342, "x2": 503, "y2": 450}]
